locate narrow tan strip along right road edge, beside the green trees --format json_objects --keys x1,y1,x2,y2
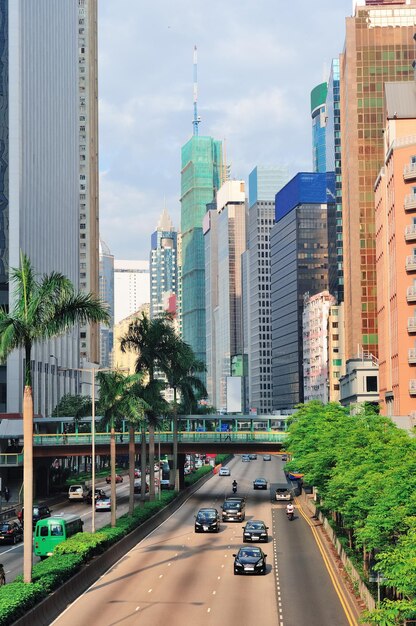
[{"x1": 296, "y1": 491, "x2": 368, "y2": 626}]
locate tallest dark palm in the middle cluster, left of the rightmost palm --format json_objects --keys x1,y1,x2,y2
[{"x1": 120, "y1": 313, "x2": 174, "y2": 499}]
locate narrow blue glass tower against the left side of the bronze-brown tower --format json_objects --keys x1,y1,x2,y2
[{"x1": 325, "y1": 59, "x2": 344, "y2": 302}]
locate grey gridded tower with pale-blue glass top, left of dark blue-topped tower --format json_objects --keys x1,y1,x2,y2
[{"x1": 243, "y1": 166, "x2": 289, "y2": 414}]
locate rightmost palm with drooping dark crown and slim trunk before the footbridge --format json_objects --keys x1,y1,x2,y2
[{"x1": 164, "y1": 337, "x2": 207, "y2": 489}]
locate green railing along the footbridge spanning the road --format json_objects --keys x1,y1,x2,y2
[{"x1": 33, "y1": 431, "x2": 288, "y2": 446}]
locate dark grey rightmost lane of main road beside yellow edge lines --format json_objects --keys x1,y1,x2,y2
[{"x1": 273, "y1": 504, "x2": 349, "y2": 626}]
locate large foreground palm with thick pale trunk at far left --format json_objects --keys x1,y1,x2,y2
[{"x1": 0, "y1": 252, "x2": 110, "y2": 582}]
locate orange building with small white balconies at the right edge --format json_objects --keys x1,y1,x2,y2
[{"x1": 375, "y1": 81, "x2": 416, "y2": 417}]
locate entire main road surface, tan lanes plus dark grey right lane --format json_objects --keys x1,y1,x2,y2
[{"x1": 53, "y1": 455, "x2": 354, "y2": 626}]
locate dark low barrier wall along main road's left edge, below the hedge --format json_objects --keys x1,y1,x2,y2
[{"x1": 13, "y1": 472, "x2": 218, "y2": 626}]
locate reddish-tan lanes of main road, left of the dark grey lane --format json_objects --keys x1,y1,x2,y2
[{"x1": 55, "y1": 456, "x2": 277, "y2": 626}]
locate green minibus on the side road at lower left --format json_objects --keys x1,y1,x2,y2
[{"x1": 33, "y1": 514, "x2": 84, "y2": 559}]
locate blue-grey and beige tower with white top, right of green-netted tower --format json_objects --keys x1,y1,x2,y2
[{"x1": 204, "y1": 180, "x2": 246, "y2": 409}]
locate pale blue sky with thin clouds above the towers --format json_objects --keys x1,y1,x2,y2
[{"x1": 98, "y1": 0, "x2": 352, "y2": 259}]
